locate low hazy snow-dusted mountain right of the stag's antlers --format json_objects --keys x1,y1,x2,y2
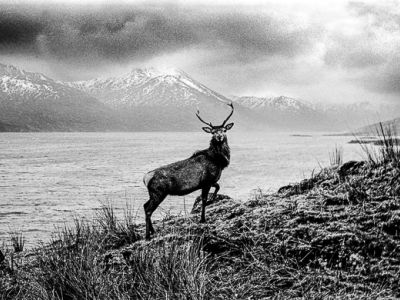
[{"x1": 232, "y1": 96, "x2": 400, "y2": 131}]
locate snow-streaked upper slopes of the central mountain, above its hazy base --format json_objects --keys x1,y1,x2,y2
[{"x1": 69, "y1": 68, "x2": 229, "y2": 108}]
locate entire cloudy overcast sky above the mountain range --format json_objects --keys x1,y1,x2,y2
[{"x1": 0, "y1": 0, "x2": 400, "y2": 103}]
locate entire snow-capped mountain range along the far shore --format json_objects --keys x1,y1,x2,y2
[{"x1": 0, "y1": 64, "x2": 393, "y2": 131}]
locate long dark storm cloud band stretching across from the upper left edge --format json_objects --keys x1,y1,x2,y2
[{"x1": 0, "y1": 5, "x2": 315, "y2": 63}]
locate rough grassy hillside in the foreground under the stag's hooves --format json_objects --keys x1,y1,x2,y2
[{"x1": 0, "y1": 133, "x2": 400, "y2": 299}]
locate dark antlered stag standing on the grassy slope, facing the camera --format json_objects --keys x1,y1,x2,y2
[{"x1": 143, "y1": 103, "x2": 234, "y2": 240}]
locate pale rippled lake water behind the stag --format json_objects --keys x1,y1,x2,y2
[{"x1": 0, "y1": 132, "x2": 362, "y2": 245}]
